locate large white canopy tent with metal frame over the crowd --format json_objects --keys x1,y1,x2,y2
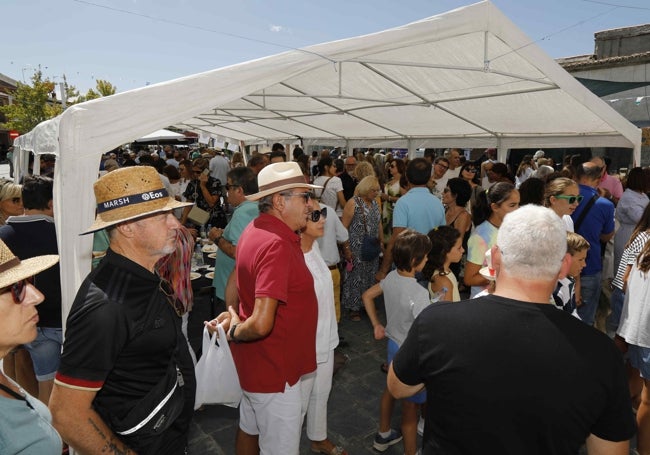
[{"x1": 10, "y1": 1, "x2": 641, "y2": 324}]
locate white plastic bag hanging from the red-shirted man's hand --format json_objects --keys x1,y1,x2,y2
[{"x1": 194, "y1": 324, "x2": 242, "y2": 409}]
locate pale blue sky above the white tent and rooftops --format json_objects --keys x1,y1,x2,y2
[{"x1": 0, "y1": 0, "x2": 650, "y2": 93}]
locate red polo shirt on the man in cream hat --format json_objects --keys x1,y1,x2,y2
[{"x1": 231, "y1": 213, "x2": 318, "y2": 393}]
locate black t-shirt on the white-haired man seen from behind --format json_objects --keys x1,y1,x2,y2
[{"x1": 393, "y1": 295, "x2": 635, "y2": 455}]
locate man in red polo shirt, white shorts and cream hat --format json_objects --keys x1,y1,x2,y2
[{"x1": 211, "y1": 162, "x2": 321, "y2": 455}]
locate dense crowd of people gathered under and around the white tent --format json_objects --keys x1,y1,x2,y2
[{"x1": 0, "y1": 144, "x2": 650, "y2": 455}]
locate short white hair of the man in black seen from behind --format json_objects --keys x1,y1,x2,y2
[{"x1": 497, "y1": 204, "x2": 567, "y2": 280}]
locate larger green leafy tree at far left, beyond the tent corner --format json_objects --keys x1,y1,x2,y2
[{"x1": 0, "y1": 68, "x2": 63, "y2": 134}]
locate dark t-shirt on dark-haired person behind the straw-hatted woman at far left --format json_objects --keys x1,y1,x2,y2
[{"x1": 0, "y1": 215, "x2": 61, "y2": 328}]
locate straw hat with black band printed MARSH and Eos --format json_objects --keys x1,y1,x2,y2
[{"x1": 82, "y1": 166, "x2": 194, "y2": 234}]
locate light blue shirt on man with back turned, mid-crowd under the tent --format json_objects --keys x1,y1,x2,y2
[{"x1": 393, "y1": 187, "x2": 446, "y2": 235}]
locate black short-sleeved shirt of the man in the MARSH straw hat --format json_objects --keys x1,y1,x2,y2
[{"x1": 56, "y1": 249, "x2": 195, "y2": 453}]
